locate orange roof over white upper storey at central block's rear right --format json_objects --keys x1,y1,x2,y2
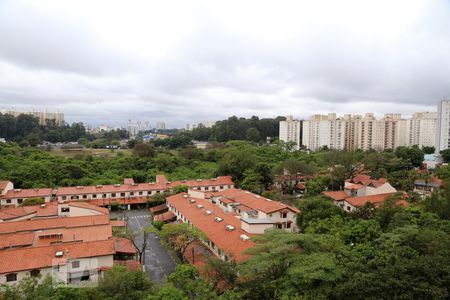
[{"x1": 211, "y1": 188, "x2": 299, "y2": 213}]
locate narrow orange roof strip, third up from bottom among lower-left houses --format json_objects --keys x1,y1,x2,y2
[{"x1": 0, "y1": 215, "x2": 109, "y2": 234}]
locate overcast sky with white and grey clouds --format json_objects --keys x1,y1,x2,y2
[{"x1": 0, "y1": 0, "x2": 450, "y2": 127}]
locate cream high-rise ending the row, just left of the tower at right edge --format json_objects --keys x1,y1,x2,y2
[{"x1": 406, "y1": 112, "x2": 438, "y2": 148}]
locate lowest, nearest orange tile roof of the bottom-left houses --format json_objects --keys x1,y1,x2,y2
[{"x1": 0, "y1": 240, "x2": 115, "y2": 274}]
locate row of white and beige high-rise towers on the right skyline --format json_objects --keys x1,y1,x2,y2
[{"x1": 286, "y1": 110, "x2": 438, "y2": 151}]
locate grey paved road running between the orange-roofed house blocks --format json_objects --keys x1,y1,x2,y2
[{"x1": 111, "y1": 210, "x2": 175, "y2": 282}]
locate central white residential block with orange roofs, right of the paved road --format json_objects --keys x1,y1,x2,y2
[{"x1": 167, "y1": 189, "x2": 298, "y2": 261}]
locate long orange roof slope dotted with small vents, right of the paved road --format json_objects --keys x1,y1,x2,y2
[{"x1": 167, "y1": 193, "x2": 254, "y2": 261}]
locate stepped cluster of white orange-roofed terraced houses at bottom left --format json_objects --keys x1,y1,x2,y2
[{"x1": 0, "y1": 202, "x2": 136, "y2": 284}]
